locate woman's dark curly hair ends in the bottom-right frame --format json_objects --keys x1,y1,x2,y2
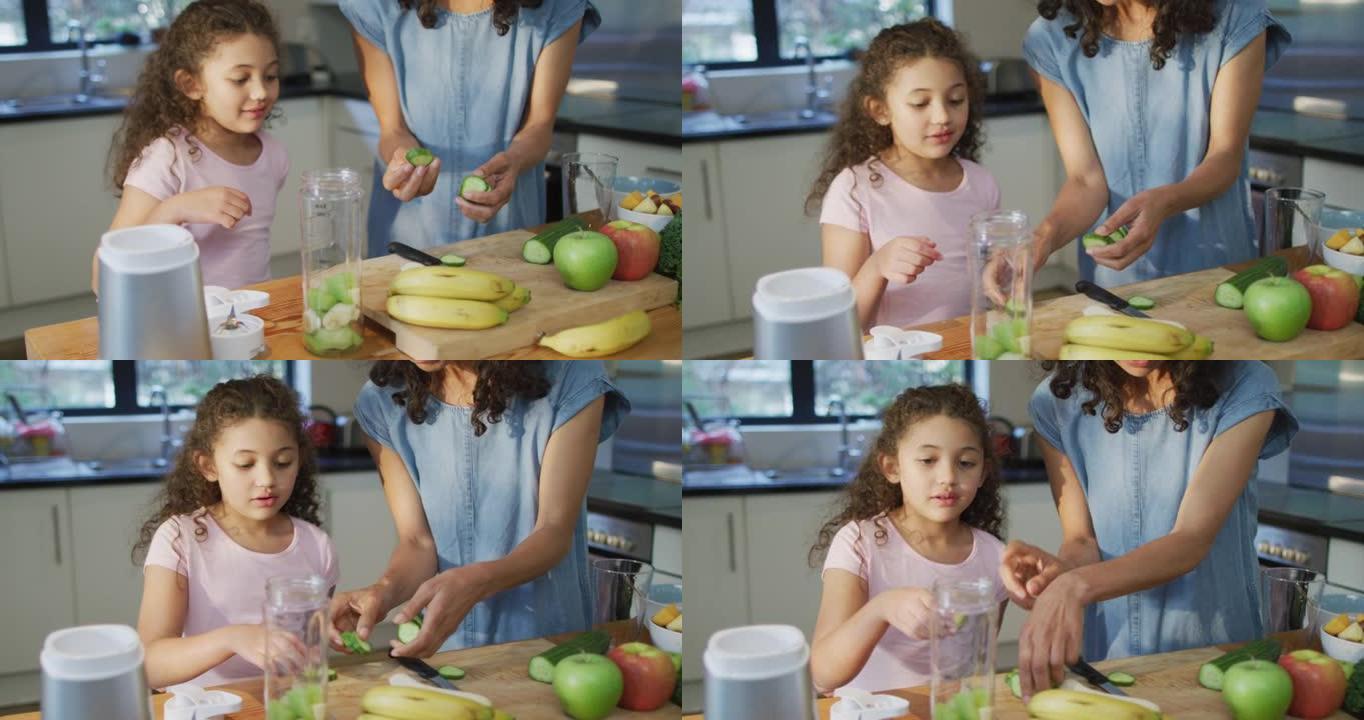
[{"x1": 1042, "y1": 360, "x2": 1228, "y2": 432}]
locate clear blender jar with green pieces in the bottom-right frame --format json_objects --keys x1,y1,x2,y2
[{"x1": 929, "y1": 577, "x2": 1000, "y2": 720}]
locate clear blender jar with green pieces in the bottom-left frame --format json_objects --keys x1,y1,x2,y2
[{"x1": 265, "y1": 575, "x2": 327, "y2": 720}]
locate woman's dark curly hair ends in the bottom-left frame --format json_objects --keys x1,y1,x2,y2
[{"x1": 370, "y1": 360, "x2": 550, "y2": 436}]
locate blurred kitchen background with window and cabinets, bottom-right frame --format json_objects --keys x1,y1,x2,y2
[{"x1": 682, "y1": 360, "x2": 1364, "y2": 712}]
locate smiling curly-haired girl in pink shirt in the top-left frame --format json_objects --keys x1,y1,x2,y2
[{"x1": 91, "y1": 0, "x2": 289, "y2": 292}]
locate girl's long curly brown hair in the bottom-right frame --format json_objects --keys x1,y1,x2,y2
[{"x1": 809, "y1": 385, "x2": 1004, "y2": 566}]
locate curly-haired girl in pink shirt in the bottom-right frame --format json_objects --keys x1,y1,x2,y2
[{"x1": 810, "y1": 385, "x2": 1008, "y2": 693}]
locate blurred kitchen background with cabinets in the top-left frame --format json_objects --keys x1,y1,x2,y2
[{"x1": 0, "y1": 0, "x2": 682, "y2": 359}]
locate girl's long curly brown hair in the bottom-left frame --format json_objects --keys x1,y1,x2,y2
[{"x1": 132, "y1": 375, "x2": 322, "y2": 562}]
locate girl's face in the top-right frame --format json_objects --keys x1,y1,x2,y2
[{"x1": 869, "y1": 57, "x2": 970, "y2": 160}]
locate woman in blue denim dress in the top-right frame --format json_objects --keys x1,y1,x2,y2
[{"x1": 1023, "y1": 0, "x2": 1292, "y2": 286}]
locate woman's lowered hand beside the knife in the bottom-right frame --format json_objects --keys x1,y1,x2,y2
[{"x1": 1019, "y1": 573, "x2": 1084, "y2": 702}]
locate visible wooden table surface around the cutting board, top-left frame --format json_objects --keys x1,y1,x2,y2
[{"x1": 23, "y1": 211, "x2": 682, "y2": 360}]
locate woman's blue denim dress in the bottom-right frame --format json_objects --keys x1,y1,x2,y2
[{"x1": 1020, "y1": 360, "x2": 1297, "y2": 660}]
